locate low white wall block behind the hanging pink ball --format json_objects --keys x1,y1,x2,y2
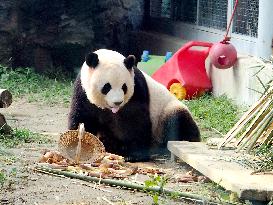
[{"x1": 206, "y1": 55, "x2": 273, "y2": 105}]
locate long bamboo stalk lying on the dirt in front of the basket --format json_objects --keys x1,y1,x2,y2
[{"x1": 35, "y1": 165, "x2": 238, "y2": 205}]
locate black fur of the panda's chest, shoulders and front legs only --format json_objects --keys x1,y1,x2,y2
[{"x1": 68, "y1": 68, "x2": 152, "y2": 161}]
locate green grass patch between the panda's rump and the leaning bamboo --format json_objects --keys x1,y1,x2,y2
[{"x1": 183, "y1": 95, "x2": 242, "y2": 138}]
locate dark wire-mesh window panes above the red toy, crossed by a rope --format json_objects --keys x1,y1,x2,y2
[{"x1": 150, "y1": 0, "x2": 259, "y2": 37}]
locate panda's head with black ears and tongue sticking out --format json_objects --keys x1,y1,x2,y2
[{"x1": 81, "y1": 49, "x2": 135, "y2": 113}]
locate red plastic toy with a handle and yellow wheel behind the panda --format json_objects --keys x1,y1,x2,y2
[{"x1": 152, "y1": 41, "x2": 213, "y2": 99}]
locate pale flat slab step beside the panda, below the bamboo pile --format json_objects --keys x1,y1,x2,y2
[{"x1": 168, "y1": 141, "x2": 273, "y2": 201}]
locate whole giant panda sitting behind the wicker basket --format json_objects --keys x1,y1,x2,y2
[{"x1": 68, "y1": 49, "x2": 200, "y2": 161}]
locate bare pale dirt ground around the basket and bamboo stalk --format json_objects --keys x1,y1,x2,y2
[{"x1": 0, "y1": 100, "x2": 216, "y2": 205}]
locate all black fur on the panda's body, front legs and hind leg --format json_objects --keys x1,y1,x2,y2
[{"x1": 68, "y1": 64, "x2": 200, "y2": 161}]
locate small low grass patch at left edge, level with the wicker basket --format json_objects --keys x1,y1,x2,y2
[{"x1": 0, "y1": 129, "x2": 51, "y2": 148}]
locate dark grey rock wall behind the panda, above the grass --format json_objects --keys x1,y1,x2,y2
[{"x1": 0, "y1": 0, "x2": 144, "y2": 71}]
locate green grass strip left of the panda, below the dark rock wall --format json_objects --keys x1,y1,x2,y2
[{"x1": 0, "y1": 65, "x2": 73, "y2": 104}]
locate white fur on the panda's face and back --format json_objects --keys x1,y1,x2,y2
[{"x1": 81, "y1": 49, "x2": 187, "y2": 141}]
